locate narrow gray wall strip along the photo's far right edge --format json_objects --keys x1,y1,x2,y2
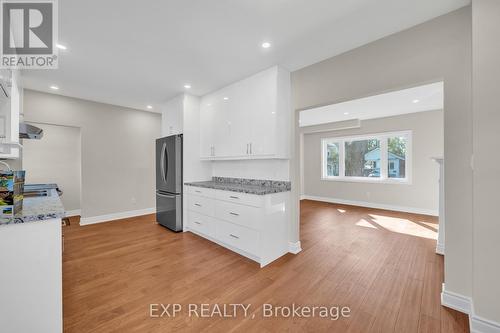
[{"x1": 472, "y1": 0, "x2": 500, "y2": 324}]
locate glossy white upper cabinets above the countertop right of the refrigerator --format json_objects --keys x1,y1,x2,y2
[{"x1": 200, "y1": 66, "x2": 291, "y2": 160}]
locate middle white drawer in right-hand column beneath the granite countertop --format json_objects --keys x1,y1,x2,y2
[{"x1": 215, "y1": 200, "x2": 262, "y2": 230}]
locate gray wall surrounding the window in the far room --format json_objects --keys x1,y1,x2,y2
[{"x1": 302, "y1": 110, "x2": 443, "y2": 215}]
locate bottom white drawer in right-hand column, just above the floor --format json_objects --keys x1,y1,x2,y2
[{"x1": 216, "y1": 221, "x2": 259, "y2": 257}]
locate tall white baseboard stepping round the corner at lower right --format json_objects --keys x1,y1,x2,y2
[{"x1": 441, "y1": 283, "x2": 500, "y2": 333}]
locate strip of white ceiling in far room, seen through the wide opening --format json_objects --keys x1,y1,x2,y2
[{"x1": 299, "y1": 82, "x2": 444, "y2": 127}]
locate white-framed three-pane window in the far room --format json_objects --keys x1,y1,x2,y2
[{"x1": 322, "y1": 131, "x2": 411, "y2": 183}]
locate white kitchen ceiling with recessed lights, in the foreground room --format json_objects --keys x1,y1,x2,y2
[{"x1": 19, "y1": 0, "x2": 470, "y2": 110}]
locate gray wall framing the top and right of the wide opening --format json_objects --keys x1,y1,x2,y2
[{"x1": 292, "y1": 7, "x2": 472, "y2": 296}]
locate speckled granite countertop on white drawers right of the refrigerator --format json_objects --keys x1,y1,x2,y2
[{"x1": 184, "y1": 177, "x2": 291, "y2": 195}]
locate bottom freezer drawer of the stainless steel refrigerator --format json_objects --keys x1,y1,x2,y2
[{"x1": 156, "y1": 192, "x2": 182, "y2": 232}]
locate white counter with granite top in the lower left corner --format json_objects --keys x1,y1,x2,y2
[{"x1": 0, "y1": 189, "x2": 65, "y2": 333}]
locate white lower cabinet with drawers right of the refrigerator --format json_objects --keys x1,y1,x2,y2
[{"x1": 186, "y1": 186, "x2": 290, "y2": 267}]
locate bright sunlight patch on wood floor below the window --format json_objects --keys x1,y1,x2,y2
[{"x1": 356, "y1": 214, "x2": 438, "y2": 239}]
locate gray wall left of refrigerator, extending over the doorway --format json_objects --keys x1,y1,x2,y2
[{"x1": 24, "y1": 90, "x2": 161, "y2": 217}]
